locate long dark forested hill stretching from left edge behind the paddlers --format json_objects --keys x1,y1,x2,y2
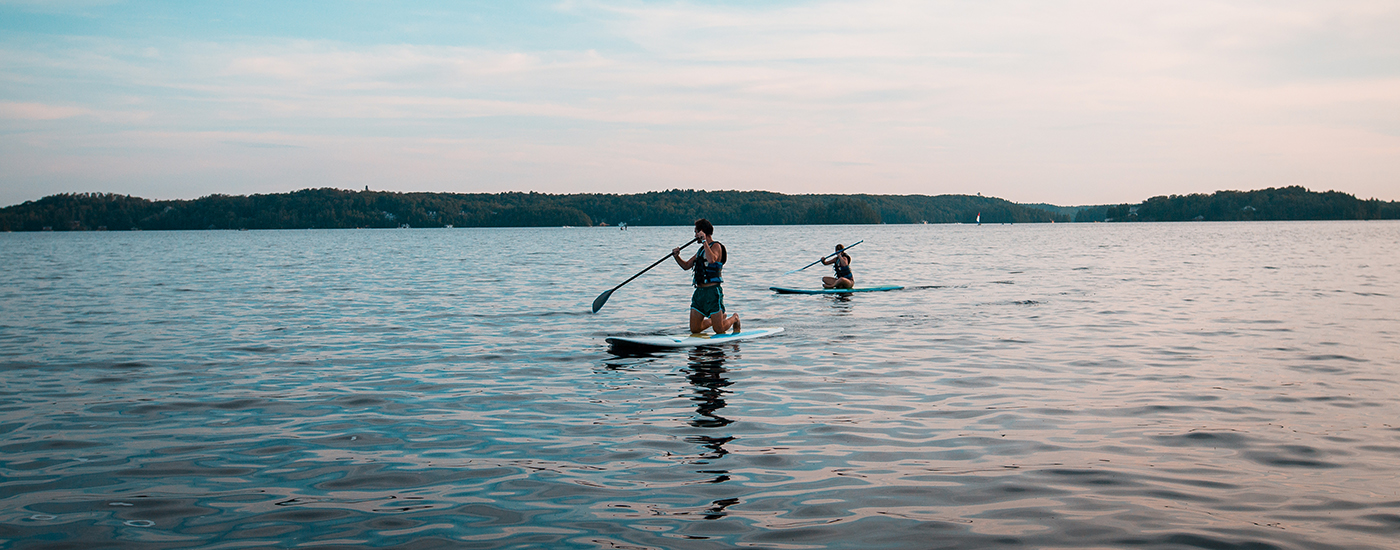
[{"x1": 0, "y1": 189, "x2": 1070, "y2": 231}]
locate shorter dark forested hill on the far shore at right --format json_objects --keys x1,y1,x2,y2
[{"x1": 1092, "y1": 186, "x2": 1400, "y2": 221}]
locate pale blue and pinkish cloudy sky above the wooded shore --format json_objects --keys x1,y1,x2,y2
[{"x1": 0, "y1": 0, "x2": 1400, "y2": 206}]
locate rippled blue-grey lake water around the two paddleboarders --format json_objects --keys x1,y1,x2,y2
[{"x1": 0, "y1": 221, "x2": 1400, "y2": 549}]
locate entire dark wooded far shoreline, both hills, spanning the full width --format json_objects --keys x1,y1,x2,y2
[{"x1": 0, "y1": 186, "x2": 1400, "y2": 231}]
